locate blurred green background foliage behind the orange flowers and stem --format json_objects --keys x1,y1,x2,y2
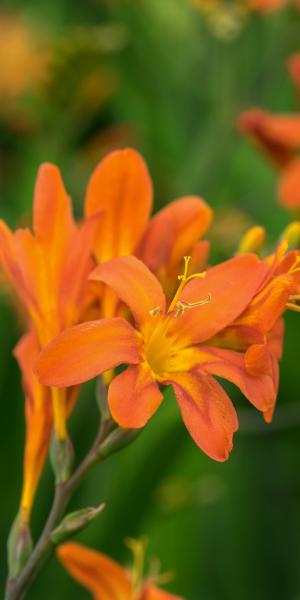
[{"x1": 0, "y1": 0, "x2": 300, "y2": 600}]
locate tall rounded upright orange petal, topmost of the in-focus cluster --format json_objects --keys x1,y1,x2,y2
[{"x1": 85, "y1": 148, "x2": 152, "y2": 262}]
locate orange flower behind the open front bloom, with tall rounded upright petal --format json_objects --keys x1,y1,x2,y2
[{"x1": 85, "y1": 148, "x2": 212, "y2": 317}]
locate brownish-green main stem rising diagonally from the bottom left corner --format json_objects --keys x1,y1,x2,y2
[{"x1": 5, "y1": 420, "x2": 137, "y2": 600}]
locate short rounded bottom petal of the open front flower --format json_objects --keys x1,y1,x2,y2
[{"x1": 108, "y1": 366, "x2": 163, "y2": 429}]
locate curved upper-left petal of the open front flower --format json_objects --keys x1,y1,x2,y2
[{"x1": 90, "y1": 256, "x2": 166, "y2": 324}]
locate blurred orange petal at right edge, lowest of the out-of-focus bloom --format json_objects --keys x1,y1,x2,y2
[{"x1": 278, "y1": 158, "x2": 300, "y2": 210}]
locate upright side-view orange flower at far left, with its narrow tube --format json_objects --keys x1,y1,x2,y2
[{"x1": 0, "y1": 164, "x2": 98, "y2": 439}]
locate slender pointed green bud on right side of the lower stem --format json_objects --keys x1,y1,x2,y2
[{"x1": 50, "y1": 504, "x2": 105, "y2": 545}]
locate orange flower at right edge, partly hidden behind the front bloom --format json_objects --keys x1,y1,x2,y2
[{"x1": 210, "y1": 242, "x2": 300, "y2": 422}]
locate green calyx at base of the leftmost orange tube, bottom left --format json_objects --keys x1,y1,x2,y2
[{"x1": 7, "y1": 511, "x2": 32, "y2": 577}]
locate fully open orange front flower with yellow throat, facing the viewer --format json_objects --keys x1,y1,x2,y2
[{"x1": 37, "y1": 254, "x2": 275, "y2": 461}]
